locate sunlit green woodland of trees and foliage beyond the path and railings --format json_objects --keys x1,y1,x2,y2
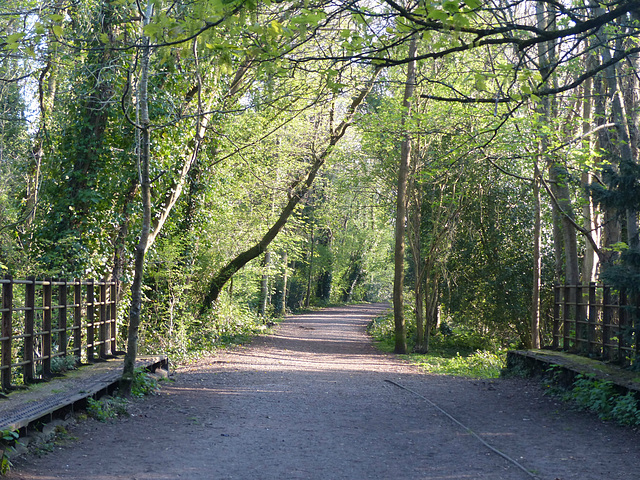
[{"x1": 0, "y1": 0, "x2": 640, "y2": 376}]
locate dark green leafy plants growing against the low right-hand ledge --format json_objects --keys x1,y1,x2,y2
[{"x1": 563, "y1": 375, "x2": 640, "y2": 425}]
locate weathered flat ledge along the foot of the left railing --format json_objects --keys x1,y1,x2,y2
[{"x1": 0, "y1": 355, "x2": 168, "y2": 431}]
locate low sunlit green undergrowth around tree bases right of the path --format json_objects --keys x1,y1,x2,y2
[{"x1": 368, "y1": 313, "x2": 507, "y2": 378}]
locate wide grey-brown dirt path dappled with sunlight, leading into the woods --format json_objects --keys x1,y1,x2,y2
[{"x1": 8, "y1": 305, "x2": 640, "y2": 480}]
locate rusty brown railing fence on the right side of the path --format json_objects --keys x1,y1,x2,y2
[{"x1": 553, "y1": 283, "x2": 640, "y2": 365}]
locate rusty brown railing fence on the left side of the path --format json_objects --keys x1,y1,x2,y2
[{"x1": 0, "y1": 277, "x2": 117, "y2": 391}]
